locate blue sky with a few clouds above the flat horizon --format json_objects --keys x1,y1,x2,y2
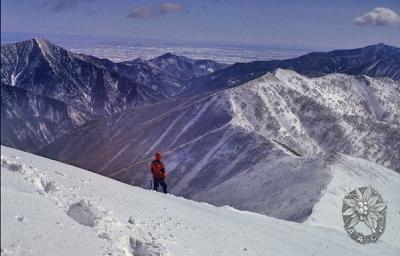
[{"x1": 1, "y1": 0, "x2": 400, "y2": 49}]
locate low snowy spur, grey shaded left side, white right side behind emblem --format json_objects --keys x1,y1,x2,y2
[{"x1": 199, "y1": 154, "x2": 400, "y2": 248}]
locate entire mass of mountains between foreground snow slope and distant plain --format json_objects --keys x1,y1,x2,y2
[{"x1": 1, "y1": 39, "x2": 400, "y2": 221}]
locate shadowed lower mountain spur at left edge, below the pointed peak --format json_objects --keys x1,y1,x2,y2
[{"x1": 1, "y1": 84, "x2": 74, "y2": 151}]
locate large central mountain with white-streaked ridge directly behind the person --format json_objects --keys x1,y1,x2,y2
[{"x1": 40, "y1": 70, "x2": 400, "y2": 224}]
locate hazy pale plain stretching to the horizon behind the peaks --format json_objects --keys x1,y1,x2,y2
[{"x1": 1, "y1": 30, "x2": 311, "y2": 64}]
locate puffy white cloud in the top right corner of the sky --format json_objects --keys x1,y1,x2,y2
[{"x1": 354, "y1": 7, "x2": 400, "y2": 26}]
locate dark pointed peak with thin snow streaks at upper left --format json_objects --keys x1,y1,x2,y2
[{"x1": 1, "y1": 39, "x2": 150, "y2": 121}]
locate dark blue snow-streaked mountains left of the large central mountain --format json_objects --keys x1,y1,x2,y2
[{"x1": 1, "y1": 39, "x2": 226, "y2": 151}]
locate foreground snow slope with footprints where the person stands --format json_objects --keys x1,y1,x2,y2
[{"x1": 1, "y1": 147, "x2": 400, "y2": 256}]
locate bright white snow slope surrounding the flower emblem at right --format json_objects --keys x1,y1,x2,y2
[{"x1": 305, "y1": 154, "x2": 400, "y2": 248}]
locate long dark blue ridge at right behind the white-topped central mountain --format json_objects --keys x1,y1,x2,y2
[{"x1": 189, "y1": 44, "x2": 400, "y2": 94}]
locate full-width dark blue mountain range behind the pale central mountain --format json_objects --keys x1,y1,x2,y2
[{"x1": 1, "y1": 38, "x2": 400, "y2": 152}]
